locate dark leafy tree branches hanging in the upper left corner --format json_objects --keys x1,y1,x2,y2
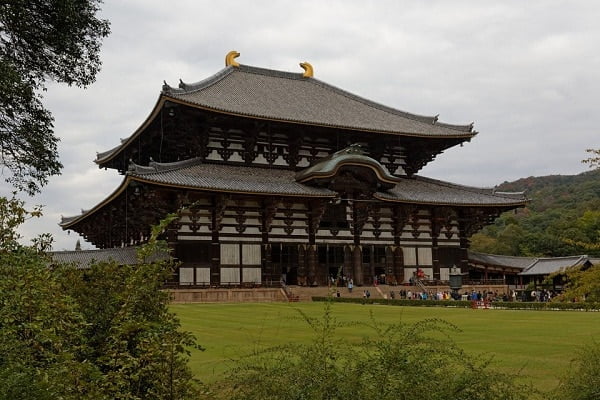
[{"x1": 0, "y1": 0, "x2": 110, "y2": 195}]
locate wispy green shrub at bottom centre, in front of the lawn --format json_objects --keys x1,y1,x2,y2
[{"x1": 213, "y1": 303, "x2": 537, "y2": 400}]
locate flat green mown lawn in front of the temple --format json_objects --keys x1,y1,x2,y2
[{"x1": 171, "y1": 303, "x2": 600, "y2": 390}]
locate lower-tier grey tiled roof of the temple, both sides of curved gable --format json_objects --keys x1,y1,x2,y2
[{"x1": 60, "y1": 158, "x2": 526, "y2": 229}]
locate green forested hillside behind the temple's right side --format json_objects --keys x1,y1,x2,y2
[{"x1": 471, "y1": 170, "x2": 600, "y2": 257}]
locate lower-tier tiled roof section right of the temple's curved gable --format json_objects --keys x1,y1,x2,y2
[{"x1": 375, "y1": 176, "x2": 527, "y2": 206}]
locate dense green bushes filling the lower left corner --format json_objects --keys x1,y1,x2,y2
[{"x1": 0, "y1": 205, "x2": 202, "y2": 400}]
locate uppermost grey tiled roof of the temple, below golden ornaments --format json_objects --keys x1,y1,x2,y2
[{"x1": 163, "y1": 65, "x2": 476, "y2": 139}]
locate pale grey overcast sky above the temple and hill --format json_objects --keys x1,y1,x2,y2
[{"x1": 5, "y1": 0, "x2": 600, "y2": 250}]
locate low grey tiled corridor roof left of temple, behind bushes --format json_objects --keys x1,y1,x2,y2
[{"x1": 49, "y1": 247, "x2": 169, "y2": 268}]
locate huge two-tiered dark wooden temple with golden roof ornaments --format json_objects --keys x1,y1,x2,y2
[{"x1": 61, "y1": 52, "x2": 526, "y2": 286}]
